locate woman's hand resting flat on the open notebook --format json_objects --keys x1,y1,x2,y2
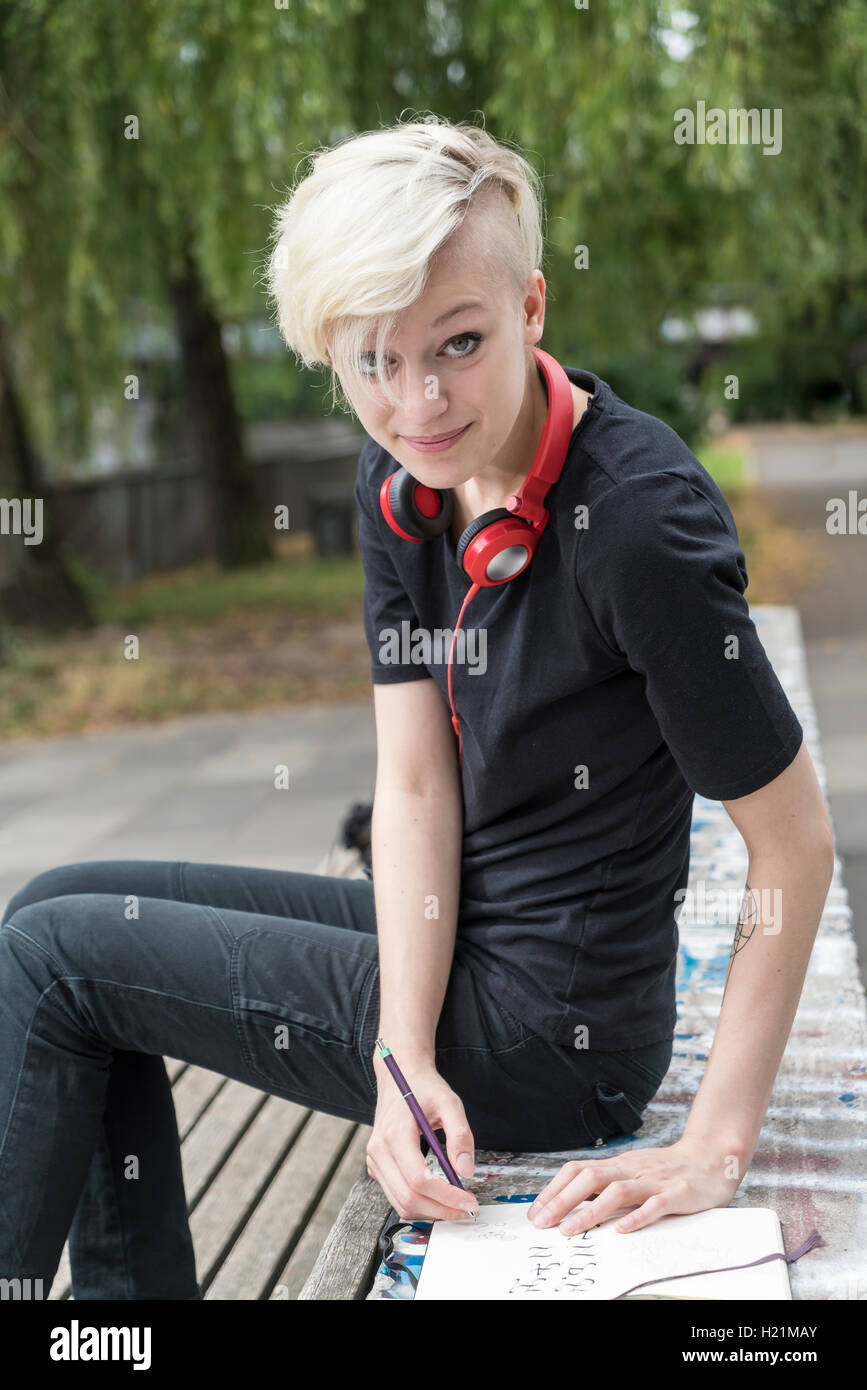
[{"x1": 528, "y1": 1137, "x2": 748, "y2": 1236}]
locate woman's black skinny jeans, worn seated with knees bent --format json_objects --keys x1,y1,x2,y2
[{"x1": 0, "y1": 859, "x2": 672, "y2": 1300}]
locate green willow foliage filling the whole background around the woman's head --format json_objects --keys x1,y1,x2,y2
[{"x1": 0, "y1": 0, "x2": 867, "y2": 452}]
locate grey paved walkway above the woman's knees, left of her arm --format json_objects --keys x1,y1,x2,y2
[{"x1": 0, "y1": 699, "x2": 377, "y2": 905}]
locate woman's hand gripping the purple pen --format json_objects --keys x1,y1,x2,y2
[{"x1": 367, "y1": 1049, "x2": 478, "y2": 1220}]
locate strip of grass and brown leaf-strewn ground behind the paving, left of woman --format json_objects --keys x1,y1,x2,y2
[{"x1": 0, "y1": 535, "x2": 370, "y2": 739}]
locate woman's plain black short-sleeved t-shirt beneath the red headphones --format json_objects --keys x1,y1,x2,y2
[{"x1": 356, "y1": 367, "x2": 803, "y2": 1049}]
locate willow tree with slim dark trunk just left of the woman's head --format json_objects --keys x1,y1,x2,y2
[{"x1": 93, "y1": 0, "x2": 480, "y2": 563}]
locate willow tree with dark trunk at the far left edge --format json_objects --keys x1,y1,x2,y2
[{"x1": 0, "y1": 11, "x2": 100, "y2": 659}]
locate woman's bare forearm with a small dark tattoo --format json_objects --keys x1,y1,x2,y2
[{"x1": 684, "y1": 848, "x2": 834, "y2": 1177}]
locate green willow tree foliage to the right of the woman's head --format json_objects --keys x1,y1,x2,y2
[{"x1": 461, "y1": 0, "x2": 867, "y2": 414}]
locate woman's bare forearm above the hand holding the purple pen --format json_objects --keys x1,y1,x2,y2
[{"x1": 371, "y1": 778, "x2": 463, "y2": 1062}]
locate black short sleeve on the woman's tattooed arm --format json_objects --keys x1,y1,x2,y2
[{"x1": 577, "y1": 471, "x2": 803, "y2": 801}]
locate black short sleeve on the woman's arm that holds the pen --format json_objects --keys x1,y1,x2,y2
[{"x1": 354, "y1": 439, "x2": 431, "y2": 685}]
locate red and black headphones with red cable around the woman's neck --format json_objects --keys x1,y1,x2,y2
[{"x1": 379, "y1": 348, "x2": 574, "y2": 762}]
